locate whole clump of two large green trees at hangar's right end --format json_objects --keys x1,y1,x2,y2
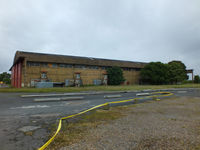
[{"x1": 141, "y1": 61, "x2": 188, "y2": 85}]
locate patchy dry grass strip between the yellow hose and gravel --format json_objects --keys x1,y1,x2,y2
[{"x1": 47, "y1": 106, "x2": 128, "y2": 150}]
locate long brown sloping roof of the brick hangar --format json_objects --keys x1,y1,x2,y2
[{"x1": 11, "y1": 51, "x2": 147, "y2": 68}]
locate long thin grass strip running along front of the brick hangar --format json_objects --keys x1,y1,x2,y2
[{"x1": 0, "y1": 84, "x2": 200, "y2": 93}]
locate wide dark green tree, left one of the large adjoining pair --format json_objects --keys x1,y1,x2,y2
[{"x1": 140, "y1": 62, "x2": 169, "y2": 85}]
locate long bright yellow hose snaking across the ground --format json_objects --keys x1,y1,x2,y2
[{"x1": 38, "y1": 92, "x2": 173, "y2": 150}]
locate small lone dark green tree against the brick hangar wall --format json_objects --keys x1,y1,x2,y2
[{"x1": 106, "y1": 67, "x2": 125, "y2": 85}]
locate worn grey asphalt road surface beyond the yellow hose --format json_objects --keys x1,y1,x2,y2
[{"x1": 0, "y1": 89, "x2": 200, "y2": 150}]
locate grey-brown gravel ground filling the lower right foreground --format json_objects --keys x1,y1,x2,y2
[{"x1": 60, "y1": 97, "x2": 200, "y2": 150}]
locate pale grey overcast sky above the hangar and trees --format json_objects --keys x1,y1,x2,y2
[{"x1": 0, "y1": 0, "x2": 200, "y2": 74}]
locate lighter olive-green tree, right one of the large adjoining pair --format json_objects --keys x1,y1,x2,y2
[{"x1": 168, "y1": 61, "x2": 188, "y2": 84}]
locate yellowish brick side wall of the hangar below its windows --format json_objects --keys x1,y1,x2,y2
[{"x1": 21, "y1": 61, "x2": 139, "y2": 87}]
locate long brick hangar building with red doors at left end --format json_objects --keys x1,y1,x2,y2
[{"x1": 10, "y1": 51, "x2": 147, "y2": 88}]
